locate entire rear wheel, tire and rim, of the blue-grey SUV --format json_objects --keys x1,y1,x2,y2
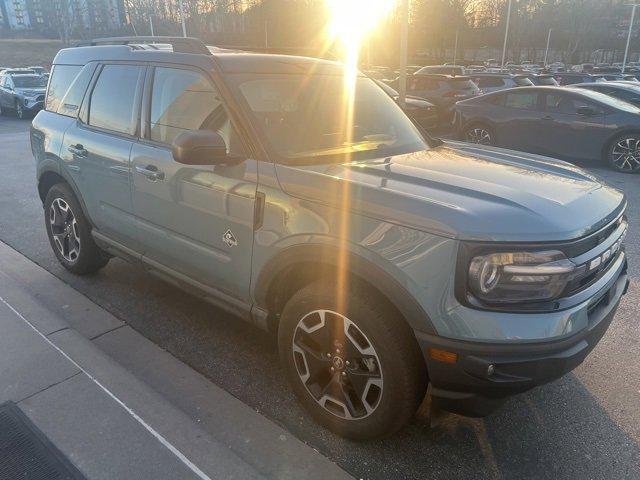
[{"x1": 44, "y1": 183, "x2": 109, "y2": 275}]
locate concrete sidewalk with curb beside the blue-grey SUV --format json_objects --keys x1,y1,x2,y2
[{"x1": 0, "y1": 243, "x2": 351, "y2": 480}]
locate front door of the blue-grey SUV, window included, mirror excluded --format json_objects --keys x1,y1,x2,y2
[{"x1": 131, "y1": 67, "x2": 257, "y2": 301}]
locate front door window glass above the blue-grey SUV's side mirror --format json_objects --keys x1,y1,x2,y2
[{"x1": 150, "y1": 67, "x2": 238, "y2": 150}]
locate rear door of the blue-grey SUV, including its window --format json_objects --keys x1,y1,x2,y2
[{"x1": 60, "y1": 64, "x2": 146, "y2": 250}]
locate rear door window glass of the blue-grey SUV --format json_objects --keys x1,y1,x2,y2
[{"x1": 89, "y1": 65, "x2": 144, "y2": 135}]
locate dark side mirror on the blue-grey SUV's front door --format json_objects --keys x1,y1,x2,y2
[{"x1": 171, "y1": 130, "x2": 227, "y2": 165}]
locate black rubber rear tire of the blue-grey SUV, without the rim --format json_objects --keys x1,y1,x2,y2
[{"x1": 44, "y1": 183, "x2": 108, "y2": 274}]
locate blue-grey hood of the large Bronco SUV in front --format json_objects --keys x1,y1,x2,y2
[{"x1": 277, "y1": 142, "x2": 626, "y2": 242}]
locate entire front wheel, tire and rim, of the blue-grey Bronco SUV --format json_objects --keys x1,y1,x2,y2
[{"x1": 278, "y1": 281, "x2": 428, "y2": 440}]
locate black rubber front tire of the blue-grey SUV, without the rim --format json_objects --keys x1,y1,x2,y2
[{"x1": 278, "y1": 282, "x2": 427, "y2": 440}]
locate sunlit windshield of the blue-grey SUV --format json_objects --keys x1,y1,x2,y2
[{"x1": 231, "y1": 74, "x2": 428, "y2": 163}]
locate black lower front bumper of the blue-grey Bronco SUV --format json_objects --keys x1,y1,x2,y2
[{"x1": 416, "y1": 261, "x2": 629, "y2": 416}]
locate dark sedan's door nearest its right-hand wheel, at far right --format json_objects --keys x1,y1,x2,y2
[{"x1": 542, "y1": 91, "x2": 609, "y2": 159}]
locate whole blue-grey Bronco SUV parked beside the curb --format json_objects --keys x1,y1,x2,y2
[{"x1": 31, "y1": 37, "x2": 628, "y2": 439}]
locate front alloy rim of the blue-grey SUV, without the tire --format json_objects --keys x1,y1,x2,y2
[{"x1": 292, "y1": 310, "x2": 383, "y2": 420}]
